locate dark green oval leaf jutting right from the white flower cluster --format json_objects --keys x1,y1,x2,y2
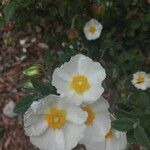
[{"x1": 111, "y1": 118, "x2": 134, "y2": 132}]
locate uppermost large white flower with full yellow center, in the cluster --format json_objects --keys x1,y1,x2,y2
[{"x1": 52, "y1": 54, "x2": 106, "y2": 105}]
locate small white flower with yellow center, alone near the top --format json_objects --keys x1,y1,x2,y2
[{"x1": 83, "y1": 19, "x2": 103, "y2": 40}]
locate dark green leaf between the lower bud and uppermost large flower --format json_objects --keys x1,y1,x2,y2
[{"x1": 31, "y1": 79, "x2": 56, "y2": 96}]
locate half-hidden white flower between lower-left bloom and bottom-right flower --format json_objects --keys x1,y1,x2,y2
[{"x1": 80, "y1": 97, "x2": 111, "y2": 144}]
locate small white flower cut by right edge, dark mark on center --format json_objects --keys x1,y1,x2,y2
[{"x1": 131, "y1": 71, "x2": 150, "y2": 90}]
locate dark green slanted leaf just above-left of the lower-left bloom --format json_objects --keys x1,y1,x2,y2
[{"x1": 14, "y1": 95, "x2": 35, "y2": 113}]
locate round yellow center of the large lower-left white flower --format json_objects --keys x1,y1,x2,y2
[{"x1": 45, "y1": 107, "x2": 67, "y2": 129}]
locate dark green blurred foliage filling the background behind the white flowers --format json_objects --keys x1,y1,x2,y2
[{"x1": 0, "y1": 0, "x2": 150, "y2": 147}]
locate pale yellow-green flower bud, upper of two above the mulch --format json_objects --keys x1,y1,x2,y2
[{"x1": 23, "y1": 64, "x2": 43, "y2": 77}]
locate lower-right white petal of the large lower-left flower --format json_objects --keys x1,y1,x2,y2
[{"x1": 64, "y1": 123, "x2": 85, "y2": 150}]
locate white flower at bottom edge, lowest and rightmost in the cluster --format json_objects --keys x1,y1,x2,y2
[{"x1": 81, "y1": 113, "x2": 127, "y2": 150}]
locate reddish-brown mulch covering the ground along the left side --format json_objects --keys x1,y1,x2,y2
[{"x1": 0, "y1": 29, "x2": 45, "y2": 150}]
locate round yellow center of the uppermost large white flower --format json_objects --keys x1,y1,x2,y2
[{"x1": 71, "y1": 74, "x2": 90, "y2": 95}]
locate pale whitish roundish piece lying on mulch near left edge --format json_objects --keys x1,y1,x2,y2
[{"x1": 3, "y1": 101, "x2": 17, "y2": 118}]
